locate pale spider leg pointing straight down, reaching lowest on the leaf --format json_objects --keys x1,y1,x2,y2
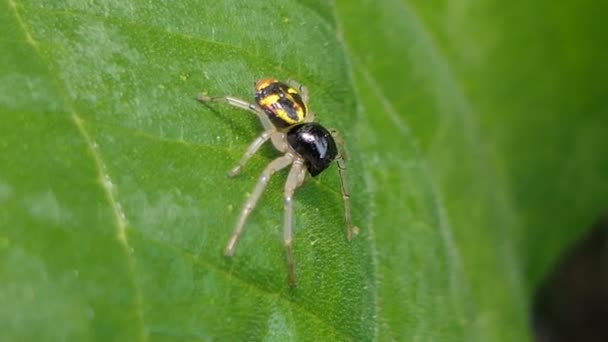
[{"x1": 283, "y1": 158, "x2": 306, "y2": 287}]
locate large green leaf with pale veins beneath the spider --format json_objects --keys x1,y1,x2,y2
[{"x1": 0, "y1": 0, "x2": 608, "y2": 341}]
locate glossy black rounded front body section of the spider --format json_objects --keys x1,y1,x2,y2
[{"x1": 287, "y1": 122, "x2": 338, "y2": 177}]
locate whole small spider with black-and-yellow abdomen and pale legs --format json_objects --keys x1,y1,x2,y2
[{"x1": 197, "y1": 78, "x2": 358, "y2": 286}]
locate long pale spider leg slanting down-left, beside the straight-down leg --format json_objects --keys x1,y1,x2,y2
[{"x1": 225, "y1": 154, "x2": 293, "y2": 256}]
